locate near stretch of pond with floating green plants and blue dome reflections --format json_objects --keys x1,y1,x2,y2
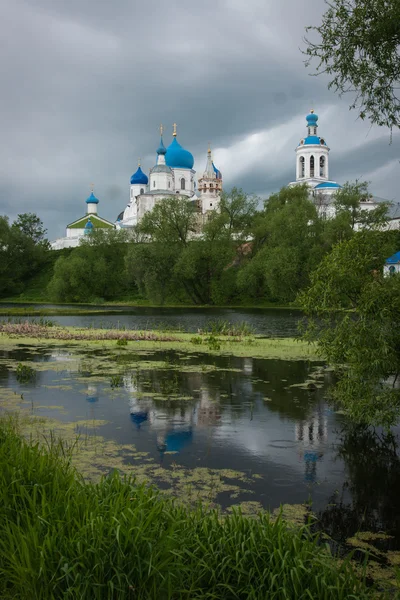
[{"x1": 0, "y1": 346, "x2": 400, "y2": 544}]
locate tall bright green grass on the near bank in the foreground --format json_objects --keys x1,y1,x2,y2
[{"x1": 0, "y1": 420, "x2": 376, "y2": 600}]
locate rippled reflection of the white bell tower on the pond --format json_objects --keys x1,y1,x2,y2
[{"x1": 295, "y1": 406, "x2": 328, "y2": 483}]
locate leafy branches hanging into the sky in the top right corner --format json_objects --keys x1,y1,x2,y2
[{"x1": 305, "y1": 0, "x2": 400, "y2": 129}]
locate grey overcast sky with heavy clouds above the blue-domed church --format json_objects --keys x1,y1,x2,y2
[{"x1": 0, "y1": 0, "x2": 400, "y2": 239}]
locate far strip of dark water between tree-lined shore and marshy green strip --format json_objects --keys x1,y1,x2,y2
[{"x1": 0, "y1": 304, "x2": 302, "y2": 337}]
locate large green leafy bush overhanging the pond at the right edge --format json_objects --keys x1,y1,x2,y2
[{"x1": 299, "y1": 231, "x2": 400, "y2": 427}]
